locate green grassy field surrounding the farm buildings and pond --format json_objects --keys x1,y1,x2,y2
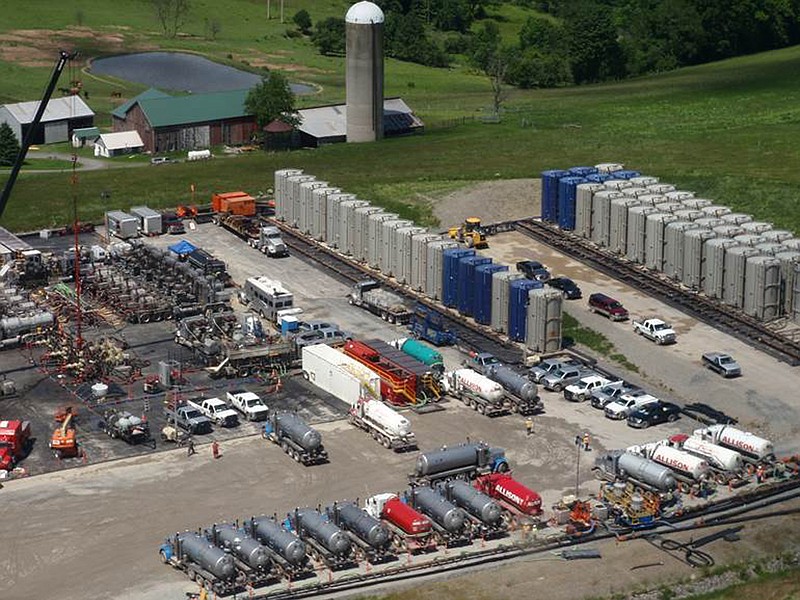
[{"x1": 0, "y1": 0, "x2": 800, "y2": 231}]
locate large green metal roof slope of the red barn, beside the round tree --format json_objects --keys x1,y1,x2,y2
[{"x1": 138, "y1": 90, "x2": 250, "y2": 127}]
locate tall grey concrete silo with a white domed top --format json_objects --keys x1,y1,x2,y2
[{"x1": 345, "y1": 2, "x2": 384, "y2": 142}]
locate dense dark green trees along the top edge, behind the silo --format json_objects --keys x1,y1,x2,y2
[{"x1": 303, "y1": 0, "x2": 800, "y2": 88}]
